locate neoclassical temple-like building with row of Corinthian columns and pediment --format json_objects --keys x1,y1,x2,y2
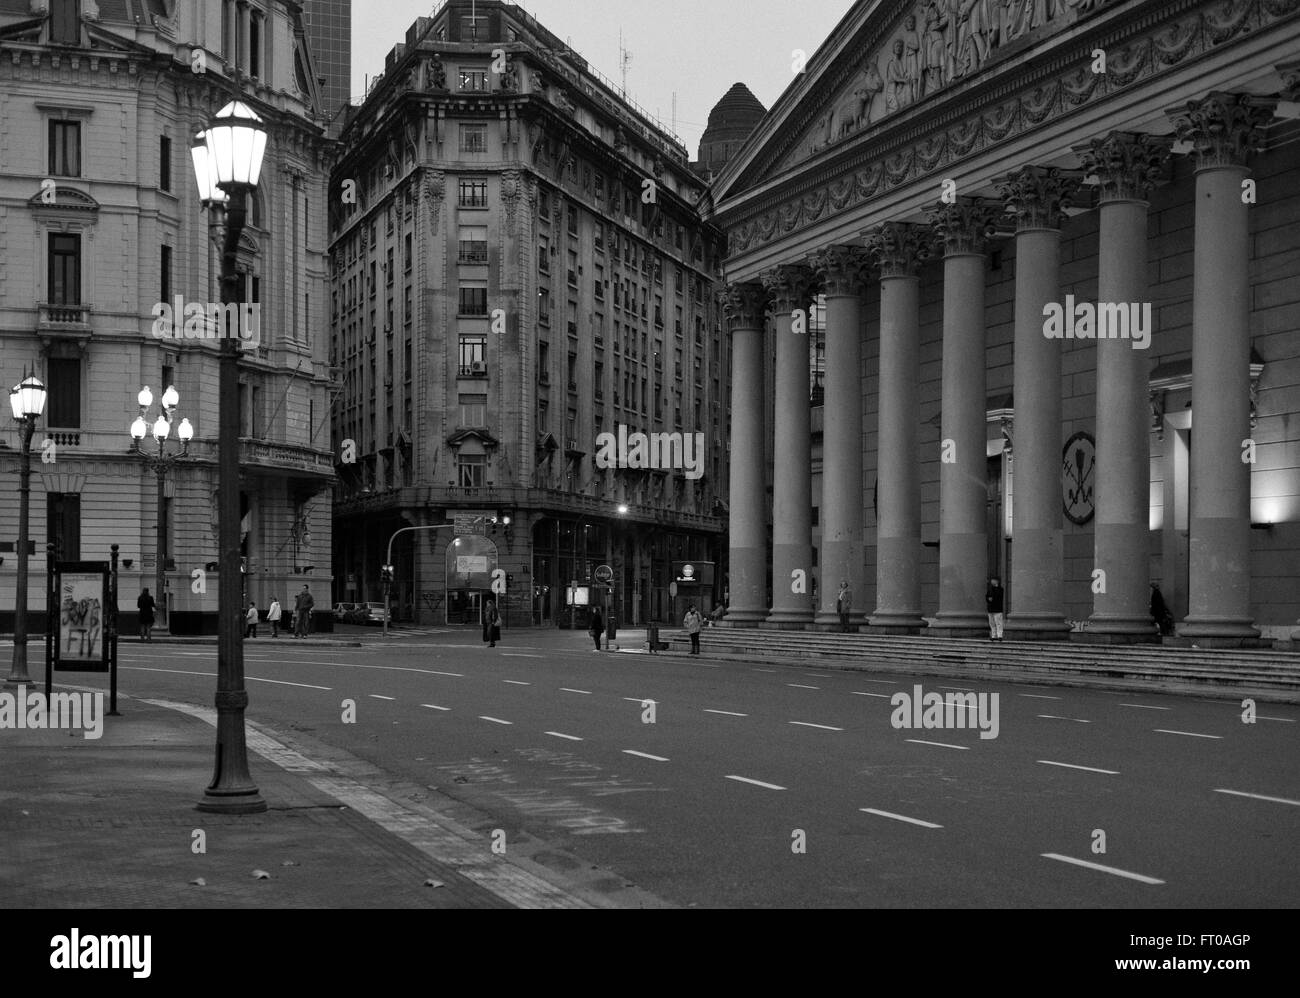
[{"x1": 709, "y1": 0, "x2": 1300, "y2": 646}]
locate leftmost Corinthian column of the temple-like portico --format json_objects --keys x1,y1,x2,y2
[{"x1": 723, "y1": 283, "x2": 767, "y2": 624}]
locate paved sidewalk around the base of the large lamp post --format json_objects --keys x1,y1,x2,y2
[{"x1": 0, "y1": 687, "x2": 636, "y2": 908}]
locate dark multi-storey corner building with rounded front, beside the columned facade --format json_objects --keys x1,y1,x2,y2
[{"x1": 329, "y1": 0, "x2": 729, "y2": 625}]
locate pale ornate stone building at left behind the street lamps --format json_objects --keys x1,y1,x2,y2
[{"x1": 0, "y1": 0, "x2": 334, "y2": 633}]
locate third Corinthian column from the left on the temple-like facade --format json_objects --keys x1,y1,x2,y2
[{"x1": 813, "y1": 246, "x2": 867, "y2": 625}]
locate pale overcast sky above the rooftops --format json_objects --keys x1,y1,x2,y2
[{"x1": 352, "y1": 0, "x2": 852, "y2": 159}]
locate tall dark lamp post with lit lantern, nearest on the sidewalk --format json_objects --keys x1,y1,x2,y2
[{"x1": 190, "y1": 100, "x2": 267, "y2": 815}]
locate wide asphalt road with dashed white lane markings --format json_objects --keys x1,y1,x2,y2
[{"x1": 86, "y1": 629, "x2": 1300, "y2": 908}]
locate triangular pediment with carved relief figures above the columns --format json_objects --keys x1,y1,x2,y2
[{"x1": 724, "y1": 0, "x2": 1115, "y2": 191}]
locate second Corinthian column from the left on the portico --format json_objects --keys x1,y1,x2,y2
[{"x1": 762, "y1": 266, "x2": 813, "y2": 625}]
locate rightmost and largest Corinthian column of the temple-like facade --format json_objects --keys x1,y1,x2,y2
[{"x1": 1170, "y1": 92, "x2": 1275, "y2": 645}]
